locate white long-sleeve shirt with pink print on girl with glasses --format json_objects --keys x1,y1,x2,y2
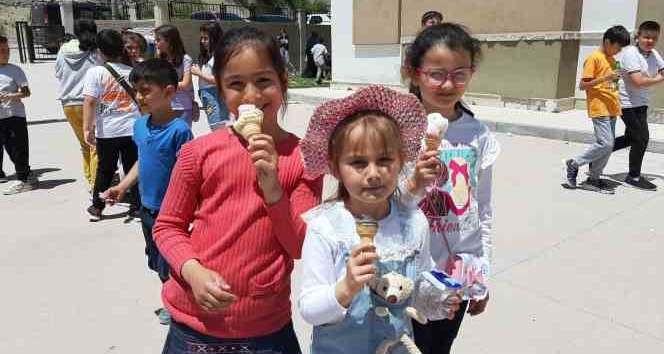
[{"x1": 400, "y1": 108, "x2": 500, "y2": 277}]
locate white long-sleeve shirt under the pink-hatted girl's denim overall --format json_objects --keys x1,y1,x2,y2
[{"x1": 298, "y1": 201, "x2": 434, "y2": 326}]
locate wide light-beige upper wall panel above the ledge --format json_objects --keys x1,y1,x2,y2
[{"x1": 401, "y1": 0, "x2": 583, "y2": 36}]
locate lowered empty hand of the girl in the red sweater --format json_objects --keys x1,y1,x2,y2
[{"x1": 181, "y1": 259, "x2": 237, "y2": 313}]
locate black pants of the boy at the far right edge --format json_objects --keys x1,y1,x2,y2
[{"x1": 613, "y1": 106, "x2": 650, "y2": 178}]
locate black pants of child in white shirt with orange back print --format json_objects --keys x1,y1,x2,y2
[{"x1": 92, "y1": 136, "x2": 140, "y2": 210}]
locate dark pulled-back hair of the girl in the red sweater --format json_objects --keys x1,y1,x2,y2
[{"x1": 212, "y1": 26, "x2": 287, "y2": 101}]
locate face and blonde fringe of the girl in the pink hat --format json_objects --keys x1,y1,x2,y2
[{"x1": 332, "y1": 116, "x2": 403, "y2": 219}]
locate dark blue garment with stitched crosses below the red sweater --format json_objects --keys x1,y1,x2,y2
[{"x1": 161, "y1": 321, "x2": 302, "y2": 354}]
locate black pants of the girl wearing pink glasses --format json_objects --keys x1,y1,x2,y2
[{"x1": 413, "y1": 301, "x2": 468, "y2": 354}]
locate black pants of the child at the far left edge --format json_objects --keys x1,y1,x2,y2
[{"x1": 0, "y1": 117, "x2": 30, "y2": 182}]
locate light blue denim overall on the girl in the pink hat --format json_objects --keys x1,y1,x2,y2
[{"x1": 311, "y1": 216, "x2": 419, "y2": 354}]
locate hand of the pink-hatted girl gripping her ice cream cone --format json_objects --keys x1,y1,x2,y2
[{"x1": 335, "y1": 243, "x2": 378, "y2": 308}]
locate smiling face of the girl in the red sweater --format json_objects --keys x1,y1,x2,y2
[{"x1": 220, "y1": 45, "x2": 287, "y2": 128}]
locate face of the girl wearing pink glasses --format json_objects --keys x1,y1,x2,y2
[{"x1": 411, "y1": 44, "x2": 472, "y2": 112}]
